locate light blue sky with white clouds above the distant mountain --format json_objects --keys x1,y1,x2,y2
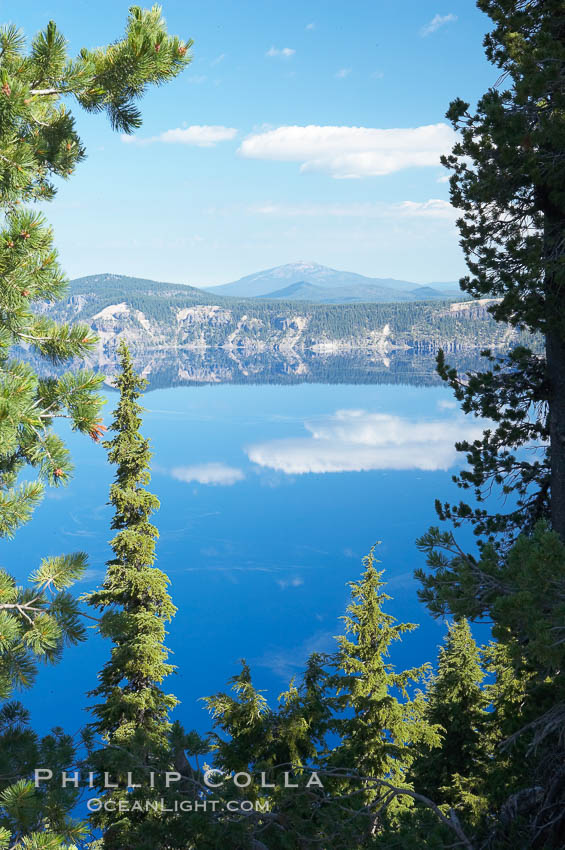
[{"x1": 6, "y1": 0, "x2": 498, "y2": 286}]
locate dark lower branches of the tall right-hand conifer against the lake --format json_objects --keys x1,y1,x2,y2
[{"x1": 436, "y1": 346, "x2": 550, "y2": 542}]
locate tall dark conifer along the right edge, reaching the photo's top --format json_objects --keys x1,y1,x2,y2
[{"x1": 420, "y1": 0, "x2": 565, "y2": 539}]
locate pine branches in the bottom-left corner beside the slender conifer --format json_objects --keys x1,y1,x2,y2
[{"x1": 0, "y1": 552, "x2": 86, "y2": 850}]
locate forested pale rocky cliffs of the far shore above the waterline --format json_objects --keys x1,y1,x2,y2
[{"x1": 39, "y1": 284, "x2": 524, "y2": 366}]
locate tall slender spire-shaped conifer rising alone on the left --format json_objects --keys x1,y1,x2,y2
[{"x1": 89, "y1": 342, "x2": 177, "y2": 850}]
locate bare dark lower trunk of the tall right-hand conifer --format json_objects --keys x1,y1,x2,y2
[{"x1": 545, "y1": 332, "x2": 565, "y2": 542}]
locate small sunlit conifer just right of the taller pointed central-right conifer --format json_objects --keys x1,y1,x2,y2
[{"x1": 411, "y1": 619, "x2": 489, "y2": 805}]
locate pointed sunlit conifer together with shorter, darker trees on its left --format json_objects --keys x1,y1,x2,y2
[{"x1": 200, "y1": 552, "x2": 459, "y2": 850}]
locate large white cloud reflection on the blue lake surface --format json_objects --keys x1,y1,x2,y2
[{"x1": 247, "y1": 410, "x2": 483, "y2": 475}]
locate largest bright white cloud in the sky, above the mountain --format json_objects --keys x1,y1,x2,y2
[{"x1": 238, "y1": 123, "x2": 456, "y2": 178}]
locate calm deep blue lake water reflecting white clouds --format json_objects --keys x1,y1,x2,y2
[{"x1": 2, "y1": 358, "x2": 490, "y2": 732}]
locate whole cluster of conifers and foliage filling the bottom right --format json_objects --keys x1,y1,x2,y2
[{"x1": 194, "y1": 527, "x2": 565, "y2": 850}]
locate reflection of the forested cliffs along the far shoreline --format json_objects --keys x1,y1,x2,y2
[{"x1": 83, "y1": 349, "x2": 485, "y2": 389}]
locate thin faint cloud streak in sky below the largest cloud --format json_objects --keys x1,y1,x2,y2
[{"x1": 248, "y1": 198, "x2": 457, "y2": 220}]
